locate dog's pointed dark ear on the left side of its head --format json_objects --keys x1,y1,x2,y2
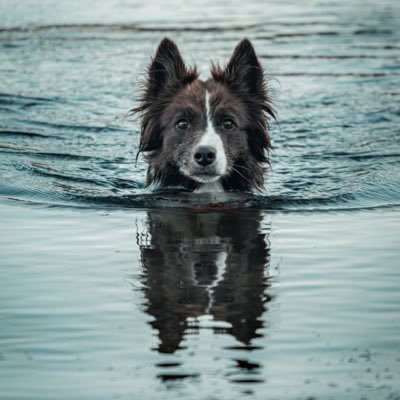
[{"x1": 147, "y1": 38, "x2": 192, "y2": 97}]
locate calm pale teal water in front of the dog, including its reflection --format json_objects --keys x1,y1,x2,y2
[{"x1": 0, "y1": 206, "x2": 400, "y2": 399}]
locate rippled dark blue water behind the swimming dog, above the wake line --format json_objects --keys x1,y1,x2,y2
[{"x1": 0, "y1": 1, "x2": 400, "y2": 210}]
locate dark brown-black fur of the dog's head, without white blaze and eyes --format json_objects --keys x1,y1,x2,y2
[{"x1": 132, "y1": 38, "x2": 275, "y2": 191}]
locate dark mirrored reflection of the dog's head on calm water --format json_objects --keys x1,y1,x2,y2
[{"x1": 138, "y1": 209, "x2": 270, "y2": 353}]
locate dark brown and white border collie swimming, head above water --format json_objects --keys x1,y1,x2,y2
[{"x1": 132, "y1": 38, "x2": 275, "y2": 192}]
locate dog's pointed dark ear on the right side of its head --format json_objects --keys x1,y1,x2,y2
[{"x1": 225, "y1": 39, "x2": 264, "y2": 91}]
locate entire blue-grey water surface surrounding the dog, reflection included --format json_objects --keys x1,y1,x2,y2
[{"x1": 0, "y1": 0, "x2": 400, "y2": 400}]
